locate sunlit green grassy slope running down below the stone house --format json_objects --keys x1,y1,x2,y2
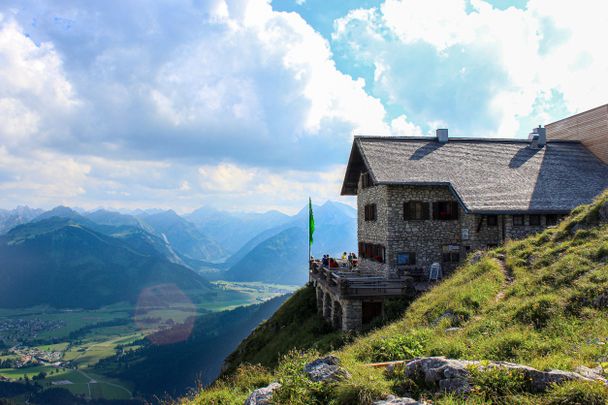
[{"x1": 188, "y1": 194, "x2": 608, "y2": 404}]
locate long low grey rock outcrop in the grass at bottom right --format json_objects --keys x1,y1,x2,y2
[{"x1": 405, "y1": 357, "x2": 608, "y2": 394}]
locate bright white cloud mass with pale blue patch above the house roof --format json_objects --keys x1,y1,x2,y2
[{"x1": 333, "y1": 0, "x2": 608, "y2": 137}]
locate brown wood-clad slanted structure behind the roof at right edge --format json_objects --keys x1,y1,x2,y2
[{"x1": 545, "y1": 104, "x2": 608, "y2": 164}]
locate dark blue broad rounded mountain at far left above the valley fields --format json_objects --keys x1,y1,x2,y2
[{"x1": 0, "y1": 217, "x2": 230, "y2": 308}]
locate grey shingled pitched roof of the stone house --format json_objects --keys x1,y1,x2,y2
[{"x1": 342, "y1": 136, "x2": 608, "y2": 213}]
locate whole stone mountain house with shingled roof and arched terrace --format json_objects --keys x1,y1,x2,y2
[{"x1": 311, "y1": 104, "x2": 608, "y2": 329}]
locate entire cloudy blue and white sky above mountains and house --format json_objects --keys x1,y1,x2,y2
[{"x1": 0, "y1": 0, "x2": 608, "y2": 213}]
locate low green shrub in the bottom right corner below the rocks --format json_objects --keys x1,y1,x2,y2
[{"x1": 547, "y1": 381, "x2": 608, "y2": 405}]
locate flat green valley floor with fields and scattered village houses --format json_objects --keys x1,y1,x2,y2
[{"x1": 0, "y1": 282, "x2": 295, "y2": 399}]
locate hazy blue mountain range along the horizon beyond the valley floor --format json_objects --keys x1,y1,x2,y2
[{"x1": 0, "y1": 202, "x2": 356, "y2": 307}]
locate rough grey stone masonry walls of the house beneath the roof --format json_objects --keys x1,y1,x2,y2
[{"x1": 357, "y1": 182, "x2": 564, "y2": 278}]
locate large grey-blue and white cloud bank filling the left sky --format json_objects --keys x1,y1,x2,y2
[{"x1": 0, "y1": 0, "x2": 389, "y2": 210}]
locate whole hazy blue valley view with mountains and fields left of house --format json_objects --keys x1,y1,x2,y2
[{"x1": 0, "y1": 201, "x2": 356, "y2": 400}]
